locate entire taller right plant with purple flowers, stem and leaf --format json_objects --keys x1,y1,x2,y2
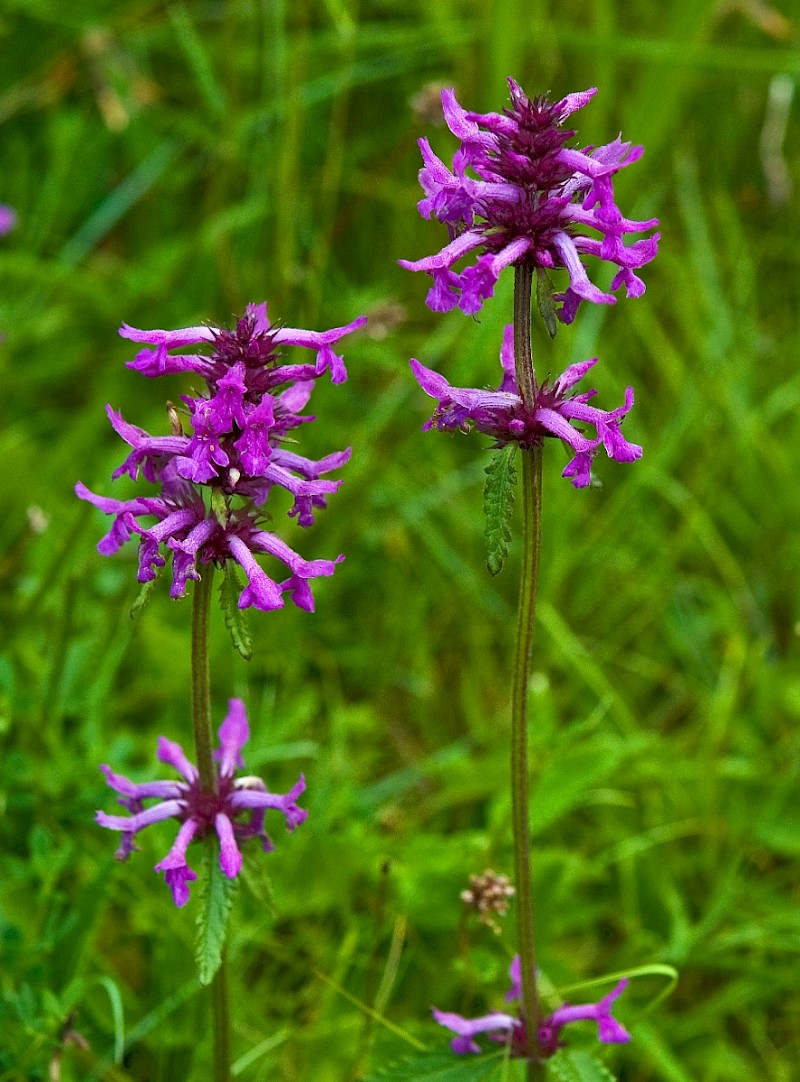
[{"x1": 401, "y1": 79, "x2": 658, "y2": 1080}]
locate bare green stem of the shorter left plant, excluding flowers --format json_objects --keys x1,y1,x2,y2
[{"x1": 192, "y1": 564, "x2": 231, "y2": 1082}]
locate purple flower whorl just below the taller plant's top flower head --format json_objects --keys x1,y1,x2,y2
[{"x1": 410, "y1": 325, "x2": 642, "y2": 488}]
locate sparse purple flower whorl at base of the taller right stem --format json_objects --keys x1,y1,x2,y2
[{"x1": 433, "y1": 955, "x2": 630, "y2": 1058}]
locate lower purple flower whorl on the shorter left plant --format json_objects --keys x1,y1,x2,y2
[{"x1": 97, "y1": 699, "x2": 309, "y2": 906}]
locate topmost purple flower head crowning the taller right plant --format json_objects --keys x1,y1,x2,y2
[{"x1": 399, "y1": 79, "x2": 659, "y2": 324}]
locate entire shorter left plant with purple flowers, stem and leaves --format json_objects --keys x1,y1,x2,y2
[{"x1": 76, "y1": 304, "x2": 366, "y2": 1082}]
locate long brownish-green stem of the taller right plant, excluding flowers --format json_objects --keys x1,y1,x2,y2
[{"x1": 511, "y1": 266, "x2": 545, "y2": 1082}]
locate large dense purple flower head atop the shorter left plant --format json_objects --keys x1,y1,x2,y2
[{"x1": 76, "y1": 304, "x2": 366, "y2": 610}]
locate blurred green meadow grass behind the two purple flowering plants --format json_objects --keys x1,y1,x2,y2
[{"x1": 0, "y1": 0, "x2": 800, "y2": 1082}]
